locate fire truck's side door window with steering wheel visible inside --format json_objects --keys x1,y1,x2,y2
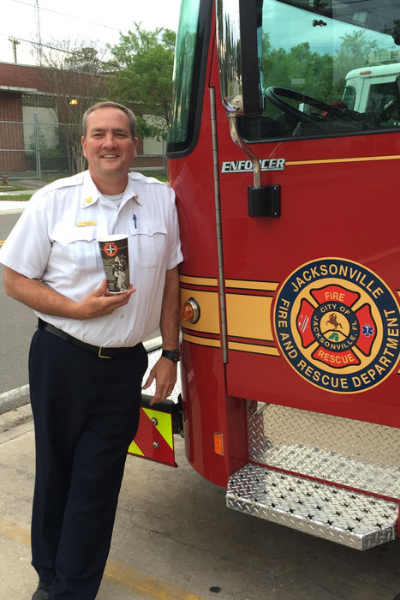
[{"x1": 239, "y1": 0, "x2": 400, "y2": 141}]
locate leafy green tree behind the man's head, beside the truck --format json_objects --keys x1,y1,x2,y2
[{"x1": 108, "y1": 23, "x2": 176, "y2": 139}]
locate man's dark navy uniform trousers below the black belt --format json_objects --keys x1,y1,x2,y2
[{"x1": 29, "y1": 330, "x2": 147, "y2": 600}]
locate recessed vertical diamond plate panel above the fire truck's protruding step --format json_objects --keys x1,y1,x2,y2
[{"x1": 248, "y1": 402, "x2": 400, "y2": 498}]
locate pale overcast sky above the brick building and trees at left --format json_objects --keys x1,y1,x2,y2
[{"x1": 0, "y1": 0, "x2": 180, "y2": 64}]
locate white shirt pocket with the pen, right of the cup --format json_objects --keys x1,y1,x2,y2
[{"x1": 129, "y1": 219, "x2": 167, "y2": 267}]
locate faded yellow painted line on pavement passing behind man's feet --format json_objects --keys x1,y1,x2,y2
[{"x1": 0, "y1": 516, "x2": 205, "y2": 600}]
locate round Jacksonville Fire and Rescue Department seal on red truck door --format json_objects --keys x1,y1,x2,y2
[{"x1": 274, "y1": 258, "x2": 400, "y2": 393}]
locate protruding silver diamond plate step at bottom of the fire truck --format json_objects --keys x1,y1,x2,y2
[{"x1": 226, "y1": 464, "x2": 399, "y2": 550}]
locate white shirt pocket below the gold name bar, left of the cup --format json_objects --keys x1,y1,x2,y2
[{"x1": 60, "y1": 226, "x2": 103, "y2": 272}]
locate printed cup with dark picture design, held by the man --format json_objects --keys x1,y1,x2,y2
[{"x1": 97, "y1": 234, "x2": 130, "y2": 294}]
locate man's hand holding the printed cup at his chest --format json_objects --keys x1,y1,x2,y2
[{"x1": 74, "y1": 279, "x2": 136, "y2": 320}]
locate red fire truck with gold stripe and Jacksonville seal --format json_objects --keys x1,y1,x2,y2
[{"x1": 130, "y1": 0, "x2": 400, "y2": 550}]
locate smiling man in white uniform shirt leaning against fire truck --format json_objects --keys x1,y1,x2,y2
[{"x1": 0, "y1": 102, "x2": 182, "y2": 600}]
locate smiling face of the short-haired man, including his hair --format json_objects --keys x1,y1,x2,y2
[{"x1": 82, "y1": 108, "x2": 138, "y2": 180}]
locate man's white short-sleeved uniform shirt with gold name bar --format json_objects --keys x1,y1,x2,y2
[{"x1": 0, "y1": 171, "x2": 182, "y2": 347}]
